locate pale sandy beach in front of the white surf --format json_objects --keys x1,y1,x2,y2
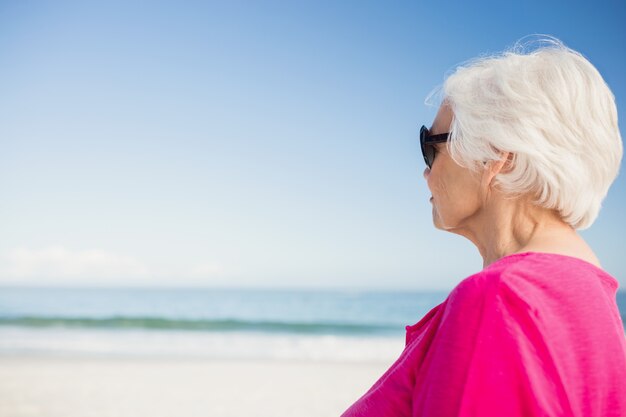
[{"x1": 0, "y1": 354, "x2": 390, "y2": 417}]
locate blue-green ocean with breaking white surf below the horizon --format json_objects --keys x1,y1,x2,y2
[{"x1": 0, "y1": 288, "x2": 626, "y2": 362}]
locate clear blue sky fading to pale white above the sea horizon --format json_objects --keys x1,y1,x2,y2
[{"x1": 0, "y1": 1, "x2": 626, "y2": 289}]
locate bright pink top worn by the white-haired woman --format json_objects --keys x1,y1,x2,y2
[{"x1": 342, "y1": 252, "x2": 626, "y2": 417}]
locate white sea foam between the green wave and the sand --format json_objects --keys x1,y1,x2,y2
[{"x1": 0, "y1": 326, "x2": 404, "y2": 362}]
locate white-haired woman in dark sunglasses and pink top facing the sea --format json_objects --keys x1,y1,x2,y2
[{"x1": 343, "y1": 38, "x2": 626, "y2": 417}]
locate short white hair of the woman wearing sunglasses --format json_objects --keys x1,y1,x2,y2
[{"x1": 426, "y1": 35, "x2": 623, "y2": 229}]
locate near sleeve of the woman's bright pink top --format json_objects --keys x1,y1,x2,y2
[{"x1": 413, "y1": 273, "x2": 571, "y2": 417}]
